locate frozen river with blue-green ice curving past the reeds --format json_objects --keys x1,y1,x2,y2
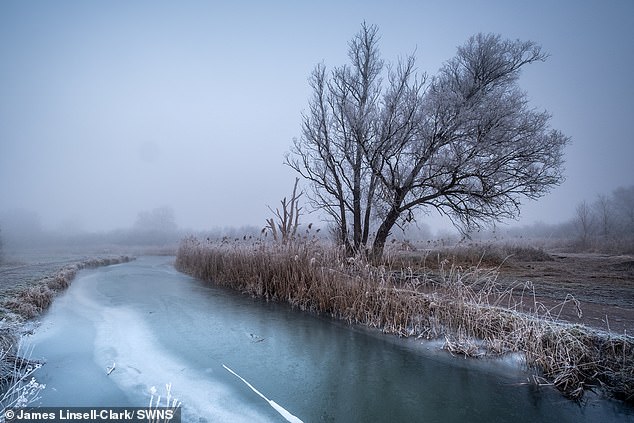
[{"x1": 26, "y1": 257, "x2": 634, "y2": 423}]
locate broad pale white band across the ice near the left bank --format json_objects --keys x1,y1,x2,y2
[{"x1": 56, "y1": 275, "x2": 276, "y2": 422}]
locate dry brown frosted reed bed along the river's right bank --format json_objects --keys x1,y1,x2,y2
[{"x1": 175, "y1": 238, "x2": 634, "y2": 401}]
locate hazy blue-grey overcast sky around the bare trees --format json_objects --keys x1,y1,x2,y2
[{"x1": 0, "y1": 0, "x2": 634, "y2": 235}]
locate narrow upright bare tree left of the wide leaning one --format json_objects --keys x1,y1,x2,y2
[{"x1": 286, "y1": 23, "x2": 383, "y2": 252}]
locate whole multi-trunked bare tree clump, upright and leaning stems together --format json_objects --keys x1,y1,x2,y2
[{"x1": 286, "y1": 24, "x2": 568, "y2": 260}]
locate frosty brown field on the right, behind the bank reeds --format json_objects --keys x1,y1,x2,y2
[{"x1": 394, "y1": 244, "x2": 634, "y2": 335}]
